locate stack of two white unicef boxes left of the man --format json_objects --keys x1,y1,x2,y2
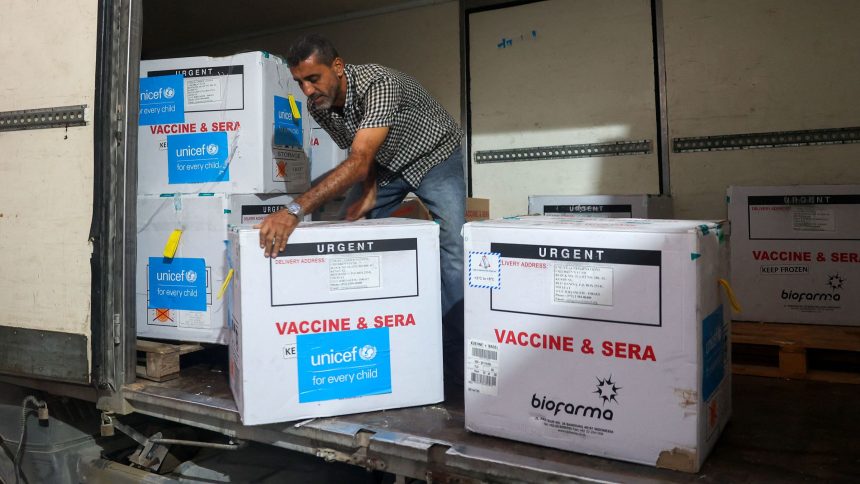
[{"x1": 137, "y1": 52, "x2": 324, "y2": 344}]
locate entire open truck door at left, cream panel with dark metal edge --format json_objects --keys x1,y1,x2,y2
[{"x1": 0, "y1": 0, "x2": 140, "y2": 400}]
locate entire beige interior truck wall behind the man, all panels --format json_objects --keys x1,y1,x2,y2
[{"x1": 143, "y1": 0, "x2": 860, "y2": 218}]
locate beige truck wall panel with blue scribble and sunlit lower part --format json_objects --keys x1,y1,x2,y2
[{"x1": 467, "y1": 0, "x2": 661, "y2": 217}]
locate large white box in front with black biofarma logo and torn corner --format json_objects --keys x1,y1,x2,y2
[{"x1": 464, "y1": 216, "x2": 731, "y2": 472}]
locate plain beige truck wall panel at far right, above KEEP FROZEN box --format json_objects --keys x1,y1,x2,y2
[{"x1": 663, "y1": 0, "x2": 860, "y2": 218}]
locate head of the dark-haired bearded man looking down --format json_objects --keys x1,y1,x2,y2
[{"x1": 287, "y1": 34, "x2": 346, "y2": 109}]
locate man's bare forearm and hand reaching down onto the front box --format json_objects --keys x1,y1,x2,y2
[{"x1": 255, "y1": 127, "x2": 388, "y2": 257}]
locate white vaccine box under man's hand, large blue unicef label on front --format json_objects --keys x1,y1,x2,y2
[{"x1": 230, "y1": 219, "x2": 443, "y2": 425}]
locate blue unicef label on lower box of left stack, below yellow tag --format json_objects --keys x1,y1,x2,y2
[{"x1": 147, "y1": 257, "x2": 206, "y2": 311}]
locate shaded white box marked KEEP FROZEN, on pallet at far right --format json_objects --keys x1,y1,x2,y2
[{"x1": 728, "y1": 185, "x2": 860, "y2": 326}]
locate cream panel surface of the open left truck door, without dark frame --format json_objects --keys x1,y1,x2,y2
[{"x1": 0, "y1": 0, "x2": 98, "y2": 356}]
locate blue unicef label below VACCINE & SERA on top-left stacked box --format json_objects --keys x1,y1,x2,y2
[{"x1": 167, "y1": 131, "x2": 230, "y2": 185}]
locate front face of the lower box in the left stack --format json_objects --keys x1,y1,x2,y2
[{"x1": 135, "y1": 194, "x2": 228, "y2": 344}]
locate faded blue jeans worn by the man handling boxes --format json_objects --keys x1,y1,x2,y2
[{"x1": 344, "y1": 147, "x2": 466, "y2": 386}]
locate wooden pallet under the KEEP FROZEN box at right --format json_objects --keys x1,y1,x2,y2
[{"x1": 732, "y1": 321, "x2": 860, "y2": 384}]
